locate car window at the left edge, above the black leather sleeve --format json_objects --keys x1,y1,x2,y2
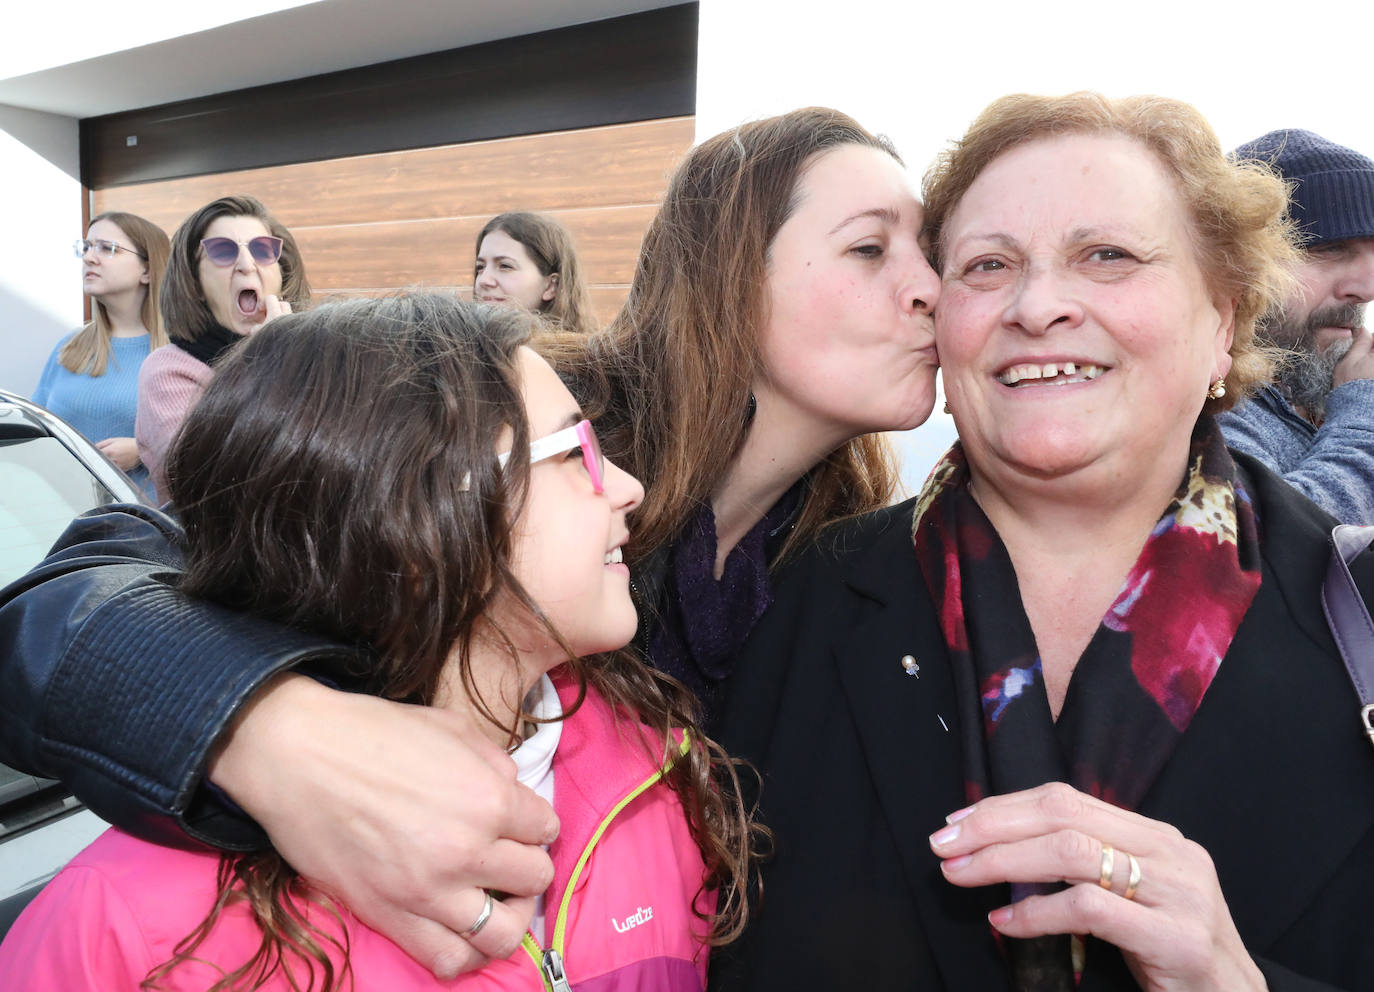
[{"x1": 0, "y1": 437, "x2": 115, "y2": 587}]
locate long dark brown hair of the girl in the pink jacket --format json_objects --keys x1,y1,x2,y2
[{"x1": 157, "y1": 294, "x2": 756, "y2": 989}]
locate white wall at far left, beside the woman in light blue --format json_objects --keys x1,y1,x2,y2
[{"x1": 0, "y1": 104, "x2": 84, "y2": 396}]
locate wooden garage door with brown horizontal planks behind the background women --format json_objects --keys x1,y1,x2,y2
[{"x1": 91, "y1": 117, "x2": 694, "y2": 322}]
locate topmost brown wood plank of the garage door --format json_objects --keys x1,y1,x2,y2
[{"x1": 95, "y1": 117, "x2": 694, "y2": 232}]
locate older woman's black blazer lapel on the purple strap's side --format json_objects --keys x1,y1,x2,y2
[{"x1": 1140, "y1": 474, "x2": 1374, "y2": 955}]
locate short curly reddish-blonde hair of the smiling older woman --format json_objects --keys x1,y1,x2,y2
[{"x1": 922, "y1": 93, "x2": 1297, "y2": 414}]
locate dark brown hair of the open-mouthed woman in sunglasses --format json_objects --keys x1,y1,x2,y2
[{"x1": 161, "y1": 194, "x2": 311, "y2": 341}]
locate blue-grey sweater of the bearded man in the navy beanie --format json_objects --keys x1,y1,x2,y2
[{"x1": 1217, "y1": 379, "x2": 1374, "y2": 523}]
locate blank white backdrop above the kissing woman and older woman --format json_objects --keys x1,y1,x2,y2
[{"x1": 697, "y1": 0, "x2": 1374, "y2": 486}]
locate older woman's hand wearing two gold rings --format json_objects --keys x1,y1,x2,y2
[{"x1": 930, "y1": 783, "x2": 1265, "y2": 992}]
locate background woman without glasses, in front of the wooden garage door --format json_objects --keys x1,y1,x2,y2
[{"x1": 473, "y1": 210, "x2": 596, "y2": 331}]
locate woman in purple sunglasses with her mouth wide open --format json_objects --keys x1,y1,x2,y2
[{"x1": 135, "y1": 195, "x2": 311, "y2": 499}]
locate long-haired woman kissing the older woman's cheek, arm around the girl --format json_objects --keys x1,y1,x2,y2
[{"x1": 0, "y1": 109, "x2": 940, "y2": 974}]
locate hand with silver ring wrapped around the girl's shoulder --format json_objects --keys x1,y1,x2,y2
[{"x1": 210, "y1": 675, "x2": 558, "y2": 978}]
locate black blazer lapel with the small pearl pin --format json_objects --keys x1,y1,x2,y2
[{"x1": 833, "y1": 517, "x2": 1007, "y2": 991}]
